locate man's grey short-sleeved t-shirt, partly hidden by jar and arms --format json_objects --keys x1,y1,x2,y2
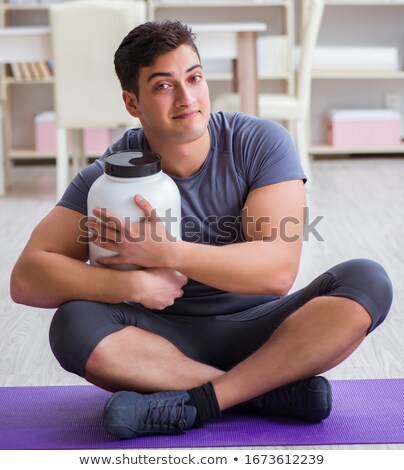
[{"x1": 58, "y1": 112, "x2": 305, "y2": 315}]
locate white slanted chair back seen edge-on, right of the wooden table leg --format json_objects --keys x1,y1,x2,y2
[{"x1": 297, "y1": 0, "x2": 324, "y2": 111}]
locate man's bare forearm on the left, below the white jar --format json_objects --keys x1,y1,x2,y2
[{"x1": 10, "y1": 251, "x2": 136, "y2": 308}]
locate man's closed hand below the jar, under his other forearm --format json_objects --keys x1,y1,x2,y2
[{"x1": 134, "y1": 268, "x2": 188, "y2": 310}]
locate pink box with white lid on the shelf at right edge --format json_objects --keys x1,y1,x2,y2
[{"x1": 327, "y1": 109, "x2": 401, "y2": 147}]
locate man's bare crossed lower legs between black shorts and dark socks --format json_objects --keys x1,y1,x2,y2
[{"x1": 85, "y1": 297, "x2": 371, "y2": 410}]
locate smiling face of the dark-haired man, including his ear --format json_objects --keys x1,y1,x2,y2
[{"x1": 124, "y1": 45, "x2": 210, "y2": 144}]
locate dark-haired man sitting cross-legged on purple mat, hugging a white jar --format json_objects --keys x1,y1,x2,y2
[{"x1": 11, "y1": 21, "x2": 392, "y2": 438}]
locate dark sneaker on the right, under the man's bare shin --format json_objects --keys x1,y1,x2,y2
[{"x1": 242, "y1": 377, "x2": 332, "y2": 421}]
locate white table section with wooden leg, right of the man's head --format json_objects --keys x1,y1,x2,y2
[{"x1": 191, "y1": 22, "x2": 267, "y2": 115}]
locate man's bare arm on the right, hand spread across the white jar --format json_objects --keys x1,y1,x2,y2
[{"x1": 92, "y1": 180, "x2": 306, "y2": 295}]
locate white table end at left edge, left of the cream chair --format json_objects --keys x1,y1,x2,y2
[{"x1": 0, "y1": 26, "x2": 51, "y2": 196}]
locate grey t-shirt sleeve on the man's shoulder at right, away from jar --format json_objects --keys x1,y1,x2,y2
[{"x1": 235, "y1": 117, "x2": 306, "y2": 190}]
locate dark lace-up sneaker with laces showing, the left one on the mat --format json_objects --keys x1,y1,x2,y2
[{"x1": 103, "y1": 391, "x2": 196, "y2": 439}]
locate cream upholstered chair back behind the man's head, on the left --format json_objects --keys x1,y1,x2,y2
[{"x1": 49, "y1": 0, "x2": 146, "y2": 129}]
